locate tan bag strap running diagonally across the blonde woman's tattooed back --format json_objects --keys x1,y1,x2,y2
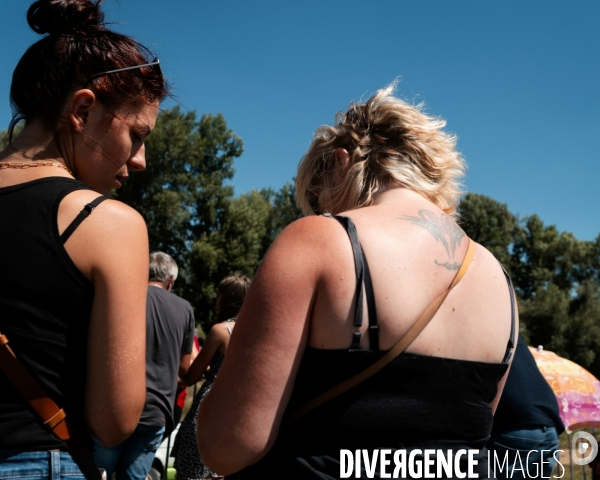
[{"x1": 288, "y1": 238, "x2": 475, "y2": 424}]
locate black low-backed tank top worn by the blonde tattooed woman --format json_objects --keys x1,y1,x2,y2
[{"x1": 227, "y1": 217, "x2": 515, "y2": 480}]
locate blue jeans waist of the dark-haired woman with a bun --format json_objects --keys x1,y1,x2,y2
[{"x1": 0, "y1": 450, "x2": 85, "y2": 480}]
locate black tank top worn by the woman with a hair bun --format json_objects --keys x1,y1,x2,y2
[{"x1": 0, "y1": 177, "x2": 102, "y2": 450}]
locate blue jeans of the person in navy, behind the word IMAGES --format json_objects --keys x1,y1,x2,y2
[{"x1": 487, "y1": 427, "x2": 558, "y2": 480}]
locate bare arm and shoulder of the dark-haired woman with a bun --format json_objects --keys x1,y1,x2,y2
[{"x1": 58, "y1": 191, "x2": 149, "y2": 446}]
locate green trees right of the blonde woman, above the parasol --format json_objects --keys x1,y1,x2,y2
[{"x1": 459, "y1": 194, "x2": 600, "y2": 376}]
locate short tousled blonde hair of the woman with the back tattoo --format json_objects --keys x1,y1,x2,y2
[{"x1": 296, "y1": 82, "x2": 466, "y2": 215}]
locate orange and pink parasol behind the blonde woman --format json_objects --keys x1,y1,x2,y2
[{"x1": 529, "y1": 347, "x2": 600, "y2": 431}]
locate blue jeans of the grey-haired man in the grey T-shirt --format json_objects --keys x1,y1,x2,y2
[{"x1": 94, "y1": 425, "x2": 165, "y2": 480}]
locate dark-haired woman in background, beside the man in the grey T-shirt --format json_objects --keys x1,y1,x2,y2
[{"x1": 172, "y1": 272, "x2": 250, "y2": 480}]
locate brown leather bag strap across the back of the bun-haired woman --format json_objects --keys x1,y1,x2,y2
[{"x1": 0, "y1": 334, "x2": 101, "y2": 480}]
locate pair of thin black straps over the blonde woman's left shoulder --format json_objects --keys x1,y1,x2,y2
[{"x1": 327, "y1": 215, "x2": 379, "y2": 350}]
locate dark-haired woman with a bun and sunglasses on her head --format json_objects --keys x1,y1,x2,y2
[{"x1": 0, "y1": 0, "x2": 167, "y2": 478}]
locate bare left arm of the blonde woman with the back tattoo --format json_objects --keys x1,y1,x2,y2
[{"x1": 198, "y1": 217, "x2": 335, "y2": 475}]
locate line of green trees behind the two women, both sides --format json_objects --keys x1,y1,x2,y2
[{"x1": 0, "y1": 107, "x2": 600, "y2": 377}]
